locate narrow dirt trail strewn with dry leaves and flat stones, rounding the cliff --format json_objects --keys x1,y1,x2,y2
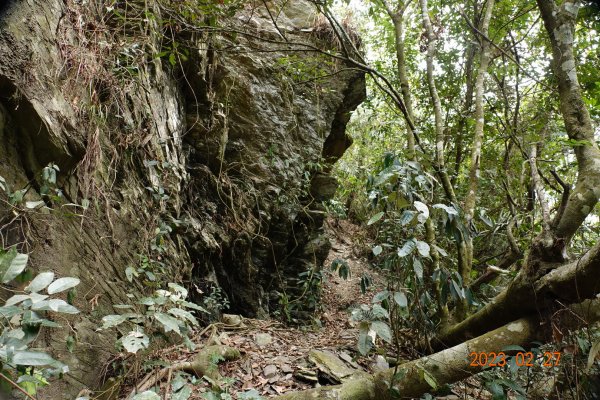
[{"x1": 214, "y1": 221, "x2": 381, "y2": 397}]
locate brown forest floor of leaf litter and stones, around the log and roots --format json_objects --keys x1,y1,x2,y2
[{"x1": 124, "y1": 220, "x2": 486, "y2": 399}]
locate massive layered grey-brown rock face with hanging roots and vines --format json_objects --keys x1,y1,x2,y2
[{"x1": 0, "y1": 0, "x2": 365, "y2": 392}]
